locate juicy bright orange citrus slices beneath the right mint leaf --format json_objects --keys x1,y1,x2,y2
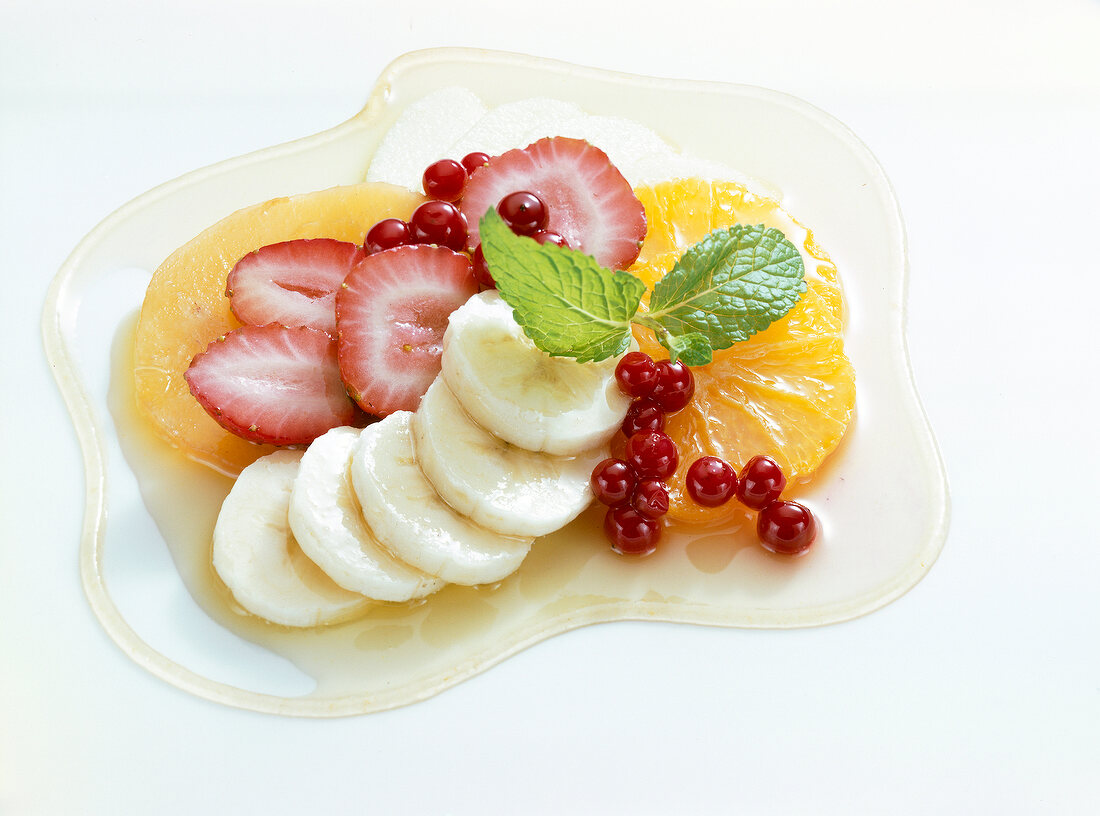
[{"x1": 630, "y1": 179, "x2": 856, "y2": 523}]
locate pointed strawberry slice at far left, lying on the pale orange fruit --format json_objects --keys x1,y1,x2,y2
[{"x1": 184, "y1": 323, "x2": 359, "y2": 445}]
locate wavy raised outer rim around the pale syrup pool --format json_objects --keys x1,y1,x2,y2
[{"x1": 42, "y1": 48, "x2": 949, "y2": 717}]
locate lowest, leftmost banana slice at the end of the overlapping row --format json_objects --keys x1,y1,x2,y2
[{"x1": 213, "y1": 451, "x2": 371, "y2": 627}]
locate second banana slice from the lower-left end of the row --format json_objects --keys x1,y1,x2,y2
[{"x1": 289, "y1": 428, "x2": 443, "y2": 602}]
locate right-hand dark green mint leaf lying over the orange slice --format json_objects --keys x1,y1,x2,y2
[{"x1": 645, "y1": 224, "x2": 806, "y2": 354}]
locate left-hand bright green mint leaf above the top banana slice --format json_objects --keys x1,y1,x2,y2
[{"x1": 479, "y1": 208, "x2": 646, "y2": 363}]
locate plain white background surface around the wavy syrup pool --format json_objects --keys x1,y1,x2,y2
[{"x1": 0, "y1": 0, "x2": 1100, "y2": 815}]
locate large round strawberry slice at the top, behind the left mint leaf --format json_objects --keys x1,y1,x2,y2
[{"x1": 462, "y1": 136, "x2": 646, "y2": 269}]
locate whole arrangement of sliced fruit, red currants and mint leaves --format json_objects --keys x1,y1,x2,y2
[{"x1": 133, "y1": 89, "x2": 855, "y2": 627}]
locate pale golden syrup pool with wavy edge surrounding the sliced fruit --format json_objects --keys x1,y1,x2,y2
[{"x1": 44, "y1": 49, "x2": 947, "y2": 716}]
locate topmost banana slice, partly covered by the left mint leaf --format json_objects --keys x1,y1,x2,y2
[{"x1": 435, "y1": 290, "x2": 630, "y2": 456}]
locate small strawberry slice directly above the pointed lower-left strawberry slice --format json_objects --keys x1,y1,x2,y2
[{"x1": 226, "y1": 238, "x2": 366, "y2": 334}]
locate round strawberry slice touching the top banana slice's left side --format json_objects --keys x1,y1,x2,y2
[{"x1": 337, "y1": 244, "x2": 477, "y2": 417}]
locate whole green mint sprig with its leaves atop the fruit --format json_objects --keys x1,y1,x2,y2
[{"x1": 480, "y1": 209, "x2": 806, "y2": 365}]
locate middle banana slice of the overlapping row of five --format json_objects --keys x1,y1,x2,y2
[{"x1": 351, "y1": 411, "x2": 531, "y2": 585}]
